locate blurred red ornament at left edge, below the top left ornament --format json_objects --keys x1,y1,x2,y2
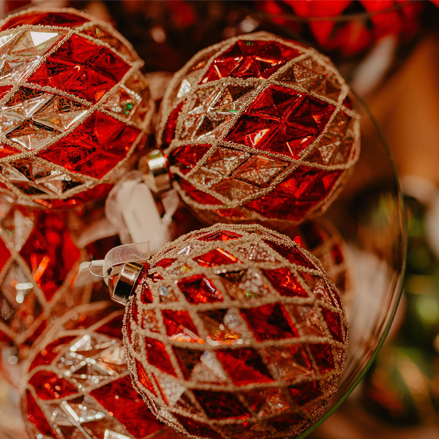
[{"x1": 0, "y1": 202, "x2": 92, "y2": 357}]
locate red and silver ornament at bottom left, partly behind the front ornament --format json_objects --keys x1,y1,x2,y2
[{"x1": 22, "y1": 302, "x2": 179, "y2": 439}]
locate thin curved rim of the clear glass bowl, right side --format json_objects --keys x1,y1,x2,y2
[{"x1": 296, "y1": 89, "x2": 407, "y2": 439}]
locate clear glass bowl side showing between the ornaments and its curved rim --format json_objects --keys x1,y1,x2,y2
[{"x1": 299, "y1": 93, "x2": 406, "y2": 438}]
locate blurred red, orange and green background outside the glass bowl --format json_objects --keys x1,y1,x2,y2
[{"x1": 0, "y1": 0, "x2": 439, "y2": 439}]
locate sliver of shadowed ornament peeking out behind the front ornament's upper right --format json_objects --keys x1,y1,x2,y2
[{"x1": 288, "y1": 218, "x2": 353, "y2": 300}]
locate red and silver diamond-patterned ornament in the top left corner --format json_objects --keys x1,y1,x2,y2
[{"x1": 0, "y1": 9, "x2": 153, "y2": 208}]
